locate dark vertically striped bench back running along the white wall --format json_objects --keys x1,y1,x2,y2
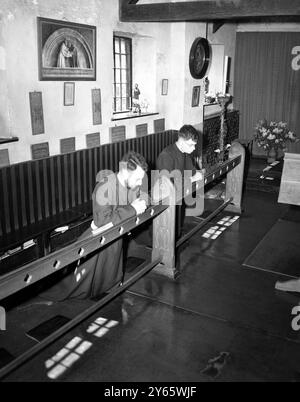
[{"x1": 0, "y1": 130, "x2": 177, "y2": 275}]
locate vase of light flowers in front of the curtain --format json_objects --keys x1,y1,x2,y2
[{"x1": 254, "y1": 119, "x2": 299, "y2": 163}]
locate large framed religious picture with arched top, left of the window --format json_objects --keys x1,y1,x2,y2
[{"x1": 37, "y1": 17, "x2": 96, "y2": 81}]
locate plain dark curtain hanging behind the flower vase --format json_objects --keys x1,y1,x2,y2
[{"x1": 234, "y1": 32, "x2": 300, "y2": 154}]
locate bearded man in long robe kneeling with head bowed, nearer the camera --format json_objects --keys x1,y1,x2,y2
[{"x1": 42, "y1": 152, "x2": 148, "y2": 301}]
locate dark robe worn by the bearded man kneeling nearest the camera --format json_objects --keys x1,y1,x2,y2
[{"x1": 42, "y1": 172, "x2": 136, "y2": 301}]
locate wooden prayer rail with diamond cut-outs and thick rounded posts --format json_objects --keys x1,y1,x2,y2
[{"x1": 0, "y1": 144, "x2": 245, "y2": 300}]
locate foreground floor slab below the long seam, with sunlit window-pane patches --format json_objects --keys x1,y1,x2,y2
[{"x1": 6, "y1": 294, "x2": 300, "y2": 382}]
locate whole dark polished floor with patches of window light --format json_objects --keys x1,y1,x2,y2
[{"x1": 0, "y1": 157, "x2": 300, "y2": 382}]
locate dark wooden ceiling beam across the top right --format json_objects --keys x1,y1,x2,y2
[{"x1": 119, "y1": 0, "x2": 300, "y2": 22}]
